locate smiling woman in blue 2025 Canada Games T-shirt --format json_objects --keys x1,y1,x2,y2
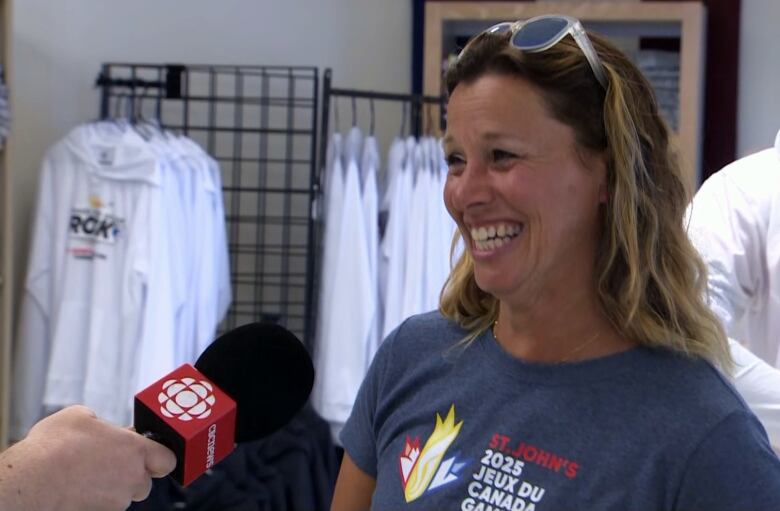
[{"x1": 333, "y1": 16, "x2": 780, "y2": 511}]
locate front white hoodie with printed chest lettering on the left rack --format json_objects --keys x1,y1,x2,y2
[{"x1": 11, "y1": 125, "x2": 168, "y2": 438}]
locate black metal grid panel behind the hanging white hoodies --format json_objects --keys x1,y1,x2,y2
[{"x1": 96, "y1": 63, "x2": 318, "y2": 347}]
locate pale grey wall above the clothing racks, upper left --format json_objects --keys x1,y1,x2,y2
[{"x1": 9, "y1": 0, "x2": 412, "y2": 314}]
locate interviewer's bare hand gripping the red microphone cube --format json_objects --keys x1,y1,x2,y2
[{"x1": 0, "y1": 406, "x2": 176, "y2": 511}]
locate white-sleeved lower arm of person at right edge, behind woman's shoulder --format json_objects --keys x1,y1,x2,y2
[{"x1": 729, "y1": 339, "x2": 780, "y2": 452}]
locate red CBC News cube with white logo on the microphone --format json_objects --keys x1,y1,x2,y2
[{"x1": 133, "y1": 364, "x2": 236, "y2": 486}]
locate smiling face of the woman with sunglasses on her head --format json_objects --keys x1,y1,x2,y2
[{"x1": 444, "y1": 74, "x2": 606, "y2": 302}]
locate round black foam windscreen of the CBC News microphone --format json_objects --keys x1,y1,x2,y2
[{"x1": 195, "y1": 323, "x2": 314, "y2": 442}]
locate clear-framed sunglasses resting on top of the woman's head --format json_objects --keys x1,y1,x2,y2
[{"x1": 458, "y1": 14, "x2": 608, "y2": 90}]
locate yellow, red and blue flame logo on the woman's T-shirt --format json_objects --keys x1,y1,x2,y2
[{"x1": 398, "y1": 404, "x2": 465, "y2": 502}]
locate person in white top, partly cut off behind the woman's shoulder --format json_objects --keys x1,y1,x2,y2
[{"x1": 688, "y1": 132, "x2": 780, "y2": 450}]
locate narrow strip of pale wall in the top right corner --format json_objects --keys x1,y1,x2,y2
[{"x1": 737, "y1": 0, "x2": 780, "y2": 156}]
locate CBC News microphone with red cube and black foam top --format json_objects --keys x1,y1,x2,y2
[{"x1": 134, "y1": 323, "x2": 314, "y2": 486}]
